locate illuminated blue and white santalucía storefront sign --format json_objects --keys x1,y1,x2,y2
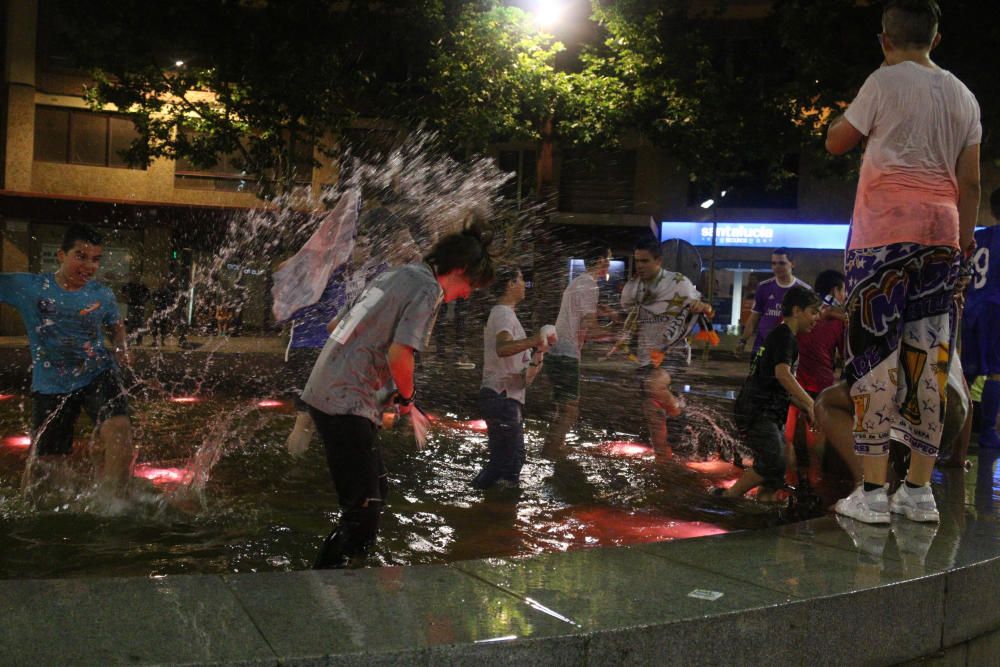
[{"x1": 660, "y1": 222, "x2": 850, "y2": 250}]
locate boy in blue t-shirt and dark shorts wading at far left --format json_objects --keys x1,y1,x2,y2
[{"x1": 0, "y1": 225, "x2": 134, "y2": 493}]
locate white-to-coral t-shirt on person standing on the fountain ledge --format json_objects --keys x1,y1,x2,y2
[{"x1": 844, "y1": 61, "x2": 983, "y2": 249}]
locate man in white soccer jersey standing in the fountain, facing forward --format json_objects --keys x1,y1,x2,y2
[{"x1": 621, "y1": 238, "x2": 712, "y2": 459}]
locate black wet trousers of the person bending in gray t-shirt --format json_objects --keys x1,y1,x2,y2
[{"x1": 309, "y1": 406, "x2": 389, "y2": 568}]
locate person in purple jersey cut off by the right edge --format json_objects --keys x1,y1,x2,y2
[{"x1": 962, "y1": 188, "x2": 1000, "y2": 448}]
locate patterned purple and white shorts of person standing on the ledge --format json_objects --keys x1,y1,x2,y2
[{"x1": 844, "y1": 243, "x2": 959, "y2": 456}]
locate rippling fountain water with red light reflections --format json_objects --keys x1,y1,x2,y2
[{"x1": 0, "y1": 397, "x2": 772, "y2": 577}]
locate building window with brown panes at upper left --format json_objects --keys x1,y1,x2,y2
[{"x1": 35, "y1": 106, "x2": 141, "y2": 169}]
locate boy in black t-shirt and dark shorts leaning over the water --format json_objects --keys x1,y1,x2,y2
[{"x1": 715, "y1": 285, "x2": 820, "y2": 500}]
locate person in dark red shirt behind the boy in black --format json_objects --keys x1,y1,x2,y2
[{"x1": 785, "y1": 269, "x2": 847, "y2": 486}]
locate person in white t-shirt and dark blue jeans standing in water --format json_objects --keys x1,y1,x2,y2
[{"x1": 472, "y1": 266, "x2": 548, "y2": 489}]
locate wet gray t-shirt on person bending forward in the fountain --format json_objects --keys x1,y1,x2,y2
[{"x1": 302, "y1": 264, "x2": 444, "y2": 425}]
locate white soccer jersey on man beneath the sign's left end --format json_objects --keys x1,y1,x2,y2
[{"x1": 622, "y1": 269, "x2": 701, "y2": 366}]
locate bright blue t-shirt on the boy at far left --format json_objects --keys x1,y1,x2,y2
[{"x1": 0, "y1": 273, "x2": 121, "y2": 394}]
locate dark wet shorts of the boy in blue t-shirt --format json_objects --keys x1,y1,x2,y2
[{"x1": 31, "y1": 368, "x2": 129, "y2": 456}]
